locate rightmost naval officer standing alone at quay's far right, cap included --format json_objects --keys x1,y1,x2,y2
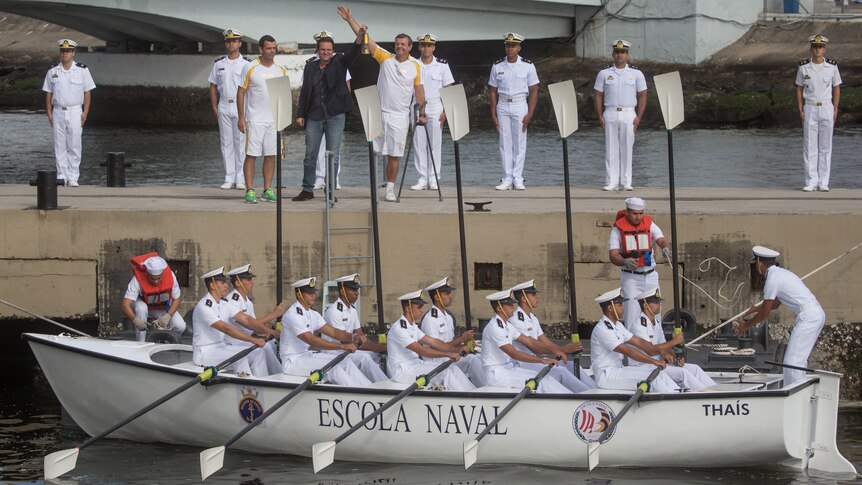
[{"x1": 796, "y1": 35, "x2": 841, "y2": 192}]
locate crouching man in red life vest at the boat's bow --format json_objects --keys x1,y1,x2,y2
[{"x1": 120, "y1": 253, "x2": 186, "y2": 342}]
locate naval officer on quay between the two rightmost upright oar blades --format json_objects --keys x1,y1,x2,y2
[{"x1": 593, "y1": 40, "x2": 647, "y2": 190}]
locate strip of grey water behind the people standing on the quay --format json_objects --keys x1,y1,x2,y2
[{"x1": 5, "y1": 112, "x2": 862, "y2": 188}]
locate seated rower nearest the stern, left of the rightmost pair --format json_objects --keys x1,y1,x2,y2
[{"x1": 590, "y1": 288, "x2": 682, "y2": 392}]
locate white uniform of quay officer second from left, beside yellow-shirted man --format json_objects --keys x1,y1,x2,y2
[{"x1": 209, "y1": 56, "x2": 249, "y2": 184}]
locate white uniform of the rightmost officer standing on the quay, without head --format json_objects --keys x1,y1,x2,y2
[{"x1": 796, "y1": 59, "x2": 841, "y2": 188}]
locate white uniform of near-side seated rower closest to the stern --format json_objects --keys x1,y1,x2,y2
[{"x1": 590, "y1": 315, "x2": 679, "y2": 392}]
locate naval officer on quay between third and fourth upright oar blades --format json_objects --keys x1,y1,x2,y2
[{"x1": 488, "y1": 32, "x2": 539, "y2": 190}]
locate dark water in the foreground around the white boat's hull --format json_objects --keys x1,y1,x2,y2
[{"x1": 0, "y1": 371, "x2": 862, "y2": 485}]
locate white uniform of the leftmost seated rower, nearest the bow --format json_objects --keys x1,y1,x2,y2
[{"x1": 192, "y1": 294, "x2": 267, "y2": 377}]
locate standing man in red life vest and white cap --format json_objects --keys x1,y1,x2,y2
[{"x1": 608, "y1": 197, "x2": 671, "y2": 332}]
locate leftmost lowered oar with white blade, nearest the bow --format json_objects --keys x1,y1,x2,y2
[{"x1": 45, "y1": 338, "x2": 258, "y2": 480}]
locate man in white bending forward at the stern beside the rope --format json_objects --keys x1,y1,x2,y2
[{"x1": 735, "y1": 246, "x2": 826, "y2": 387}]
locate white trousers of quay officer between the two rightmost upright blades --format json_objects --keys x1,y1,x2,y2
[{"x1": 604, "y1": 107, "x2": 636, "y2": 187}]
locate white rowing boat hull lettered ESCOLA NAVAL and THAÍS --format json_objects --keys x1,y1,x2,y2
[{"x1": 24, "y1": 334, "x2": 856, "y2": 474}]
